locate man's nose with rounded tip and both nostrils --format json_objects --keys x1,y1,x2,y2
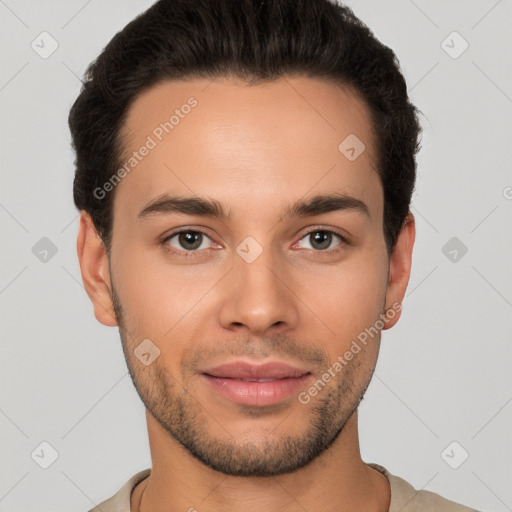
[{"x1": 219, "y1": 244, "x2": 300, "y2": 336}]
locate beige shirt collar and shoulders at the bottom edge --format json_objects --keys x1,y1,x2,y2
[{"x1": 89, "y1": 464, "x2": 478, "y2": 512}]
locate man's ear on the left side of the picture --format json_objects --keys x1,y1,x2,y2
[{"x1": 76, "y1": 210, "x2": 117, "y2": 327}]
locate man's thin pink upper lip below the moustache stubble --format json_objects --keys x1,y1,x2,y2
[{"x1": 201, "y1": 361, "x2": 310, "y2": 379}]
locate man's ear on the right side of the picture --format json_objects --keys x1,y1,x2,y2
[{"x1": 384, "y1": 212, "x2": 416, "y2": 329}]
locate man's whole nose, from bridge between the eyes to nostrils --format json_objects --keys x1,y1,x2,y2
[{"x1": 221, "y1": 237, "x2": 297, "y2": 333}]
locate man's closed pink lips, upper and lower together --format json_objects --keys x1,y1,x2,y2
[{"x1": 201, "y1": 361, "x2": 313, "y2": 407}]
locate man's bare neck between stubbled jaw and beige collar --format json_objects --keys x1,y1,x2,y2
[{"x1": 131, "y1": 411, "x2": 390, "y2": 512}]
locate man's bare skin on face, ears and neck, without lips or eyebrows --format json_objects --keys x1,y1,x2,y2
[{"x1": 77, "y1": 77, "x2": 415, "y2": 512}]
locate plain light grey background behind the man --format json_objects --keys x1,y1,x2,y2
[{"x1": 0, "y1": 0, "x2": 512, "y2": 512}]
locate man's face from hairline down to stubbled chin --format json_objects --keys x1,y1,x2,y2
[{"x1": 81, "y1": 77, "x2": 412, "y2": 476}]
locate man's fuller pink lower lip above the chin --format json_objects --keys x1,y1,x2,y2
[{"x1": 201, "y1": 373, "x2": 312, "y2": 406}]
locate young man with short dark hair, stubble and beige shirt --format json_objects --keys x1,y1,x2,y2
[{"x1": 69, "y1": 0, "x2": 482, "y2": 512}]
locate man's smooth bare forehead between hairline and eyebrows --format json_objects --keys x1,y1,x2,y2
[{"x1": 115, "y1": 73, "x2": 382, "y2": 220}]
